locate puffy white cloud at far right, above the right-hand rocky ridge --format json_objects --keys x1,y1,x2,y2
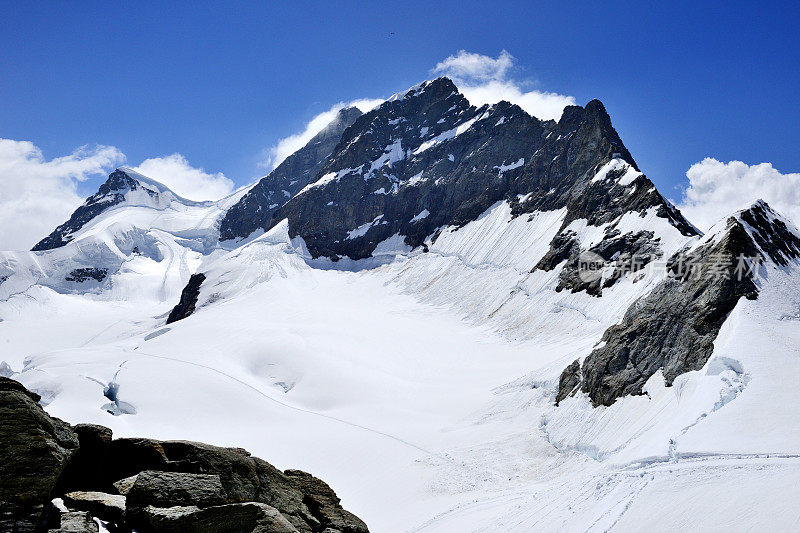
[{"x1": 678, "y1": 157, "x2": 800, "y2": 230}]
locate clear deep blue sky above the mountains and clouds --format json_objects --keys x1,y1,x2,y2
[{"x1": 0, "y1": 0, "x2": 800, "y2": 240}]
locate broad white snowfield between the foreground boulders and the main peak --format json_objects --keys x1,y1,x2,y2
[{"x1": 7, "y1": 200, "x2": 800, "y2": 531}]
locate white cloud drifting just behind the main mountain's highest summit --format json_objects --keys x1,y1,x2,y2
[{"x1": 432, "y1": 50, "x2": 575, "y2": 120}]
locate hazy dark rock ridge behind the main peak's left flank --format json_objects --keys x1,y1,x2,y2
[{"x1": 220, "y1": 107, "x2": 361, "y2": 240}]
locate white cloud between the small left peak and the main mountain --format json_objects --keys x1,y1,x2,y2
[{"x1": 133, "y1": 154, "x2": 233, "y2": 204}]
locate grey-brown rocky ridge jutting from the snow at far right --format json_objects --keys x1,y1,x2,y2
[{"x1": 556, "y1": 201, "x2": 800, "y2": 405}]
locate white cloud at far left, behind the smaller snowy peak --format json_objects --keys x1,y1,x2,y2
[{"x1": 0, "y1": 139, "x2": 125, "y2": 250}]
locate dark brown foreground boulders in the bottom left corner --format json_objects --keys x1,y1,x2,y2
[{"x1": 0, "y1": 377, "x2": 367, "y2": 533}]
